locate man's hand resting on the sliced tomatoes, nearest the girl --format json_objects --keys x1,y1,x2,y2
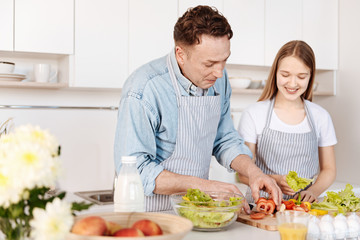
[{"x1": 249, "y1": 171, "x2": 282, "y2": 208}]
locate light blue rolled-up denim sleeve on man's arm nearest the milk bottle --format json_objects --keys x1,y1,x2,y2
[{"x1": 114, "y1": 92, "x2": 164, "y2": 196}]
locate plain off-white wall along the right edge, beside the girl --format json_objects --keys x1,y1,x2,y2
[{"x1": 316, "y1": 0, "x2": 360, "y2": 183}]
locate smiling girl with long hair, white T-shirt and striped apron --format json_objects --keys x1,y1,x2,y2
[{"x1": 238, "y1": 41, "x2": 337, "y2": 202}]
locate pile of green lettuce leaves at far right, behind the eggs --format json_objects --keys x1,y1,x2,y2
[{"x1": 311, "y1": 184, "x2": 360, "y2": 213}]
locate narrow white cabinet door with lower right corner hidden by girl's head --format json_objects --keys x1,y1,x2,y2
[{"x1": 265, "y1": 0, "x2": 302, "y2": 66}]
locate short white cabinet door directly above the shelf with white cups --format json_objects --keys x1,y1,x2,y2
[{"x1": 14, "y1": 0, "x2": 74, "y2": 54}]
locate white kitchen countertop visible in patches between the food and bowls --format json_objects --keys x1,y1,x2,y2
[{"x1": 66, "y1": 182, "x2": 360, "y2": 240}]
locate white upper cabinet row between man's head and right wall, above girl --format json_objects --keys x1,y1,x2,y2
[{"x1": 226, "y1": 0, "x2": 338, "y2": 70}]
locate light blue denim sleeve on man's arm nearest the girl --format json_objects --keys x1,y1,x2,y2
[{"x1": 213, "y1": 77, "x2": 252, "y2": 172}]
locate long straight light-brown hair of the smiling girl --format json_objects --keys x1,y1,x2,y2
[{"x1": 258, "y1": 40, "x2": 315, "y2": 101}]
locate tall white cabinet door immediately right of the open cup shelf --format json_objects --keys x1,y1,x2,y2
[{"x1": 70, "y1": 0, "x2": 128, "y2": 88}]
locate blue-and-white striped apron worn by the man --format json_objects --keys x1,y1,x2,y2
[{"x1": 145, "y1": 54, "x2": 221, "y2": 212}]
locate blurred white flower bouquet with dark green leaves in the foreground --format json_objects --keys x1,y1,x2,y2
[{"x1": 0, "y1": 125, "x2": 91, "y2": 240}]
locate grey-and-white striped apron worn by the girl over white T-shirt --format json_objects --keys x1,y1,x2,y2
[{"x1": 246, "y1": 98, "x2": 319, "y2": 202}]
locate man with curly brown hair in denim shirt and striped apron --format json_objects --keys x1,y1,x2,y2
[{"x1": 115, "y1": 6, "x2": 281, "y2": 212}]
